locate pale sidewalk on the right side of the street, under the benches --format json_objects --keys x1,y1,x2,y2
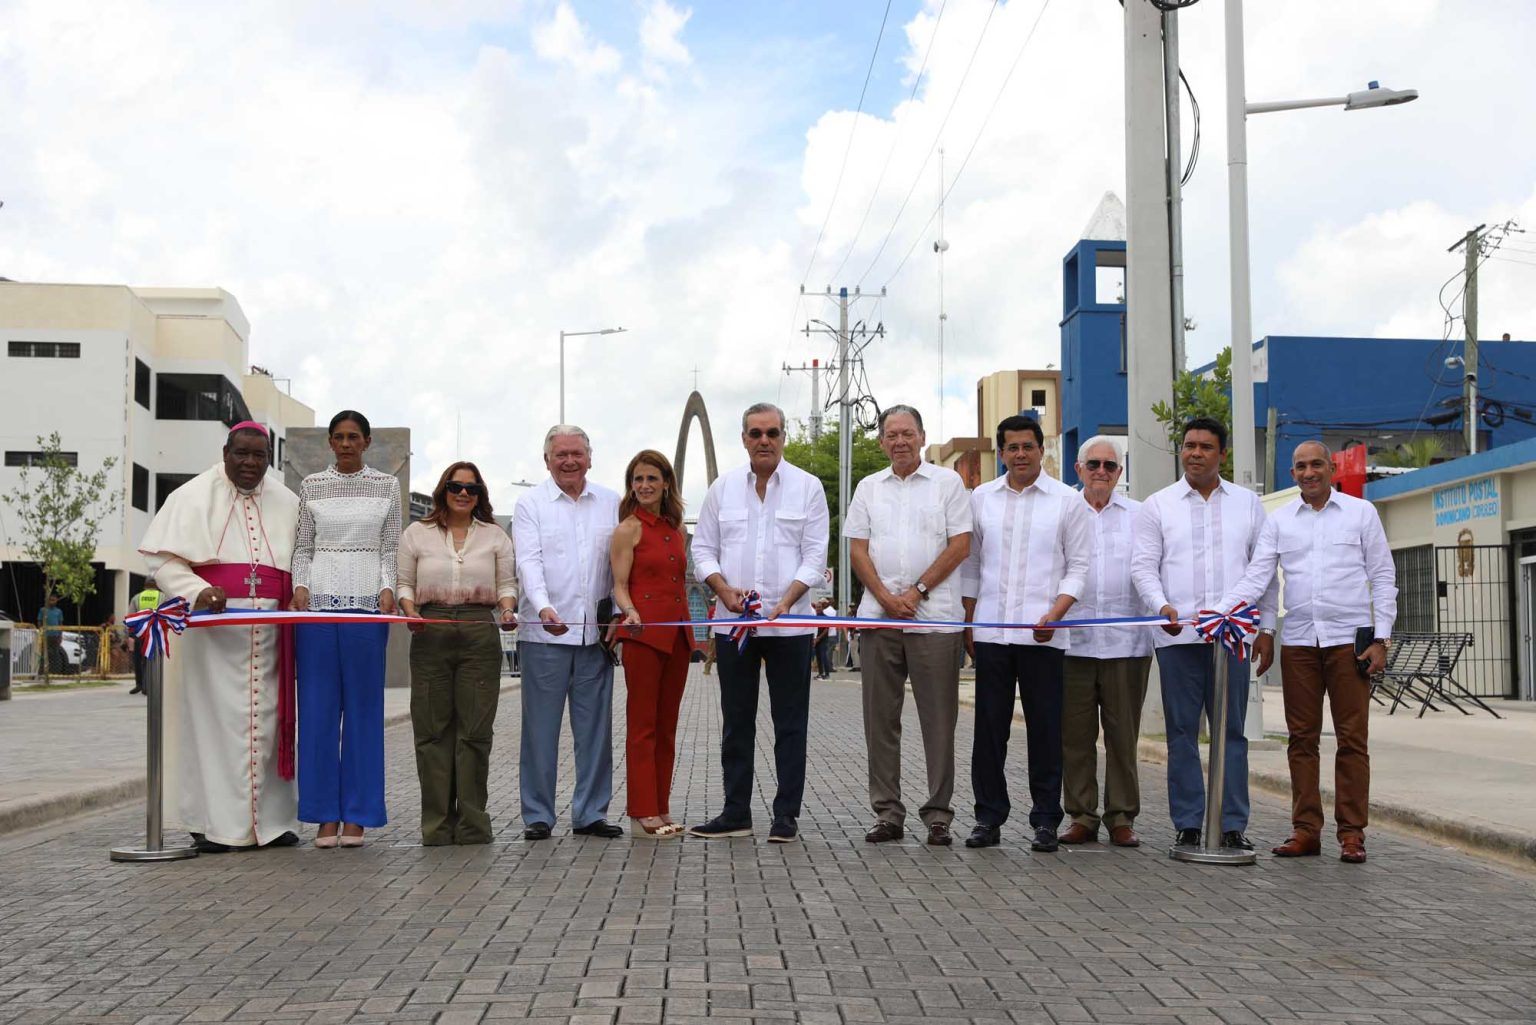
[{"x1": 960, "y1": 673, "x2": 1536, "y2": 862}]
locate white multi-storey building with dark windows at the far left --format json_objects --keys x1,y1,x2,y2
[{"x1": 0, "y1": 281, "x2": 315, "y2": 622}]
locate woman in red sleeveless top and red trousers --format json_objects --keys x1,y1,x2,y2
[{"x1": 611, "y1": 449, "x2": 693, "y2": 839}]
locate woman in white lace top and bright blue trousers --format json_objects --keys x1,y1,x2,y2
[{"x1": 289, "y1": 409, "x2": 399, "y2": 848}]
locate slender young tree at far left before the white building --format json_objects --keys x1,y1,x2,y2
[{"x1": 0, "y1": 430, "x2": 118, "y2": 682}]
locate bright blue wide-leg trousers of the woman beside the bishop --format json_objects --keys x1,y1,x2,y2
[{"x1": 293, "y1": 622, "x2": 389, "y2": 828}]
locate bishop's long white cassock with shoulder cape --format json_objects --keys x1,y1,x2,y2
[{"x1": 140, "y1": 461, "x2": 298, "y2": 847}]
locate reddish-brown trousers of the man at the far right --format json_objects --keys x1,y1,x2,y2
[{"x1": 1279, "y1": 644, "x2": 1370, "y2": 841}]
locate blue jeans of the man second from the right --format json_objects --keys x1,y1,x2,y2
[{"x1": 1157, "y1": 644, "x2": 1249, "y2": 831}]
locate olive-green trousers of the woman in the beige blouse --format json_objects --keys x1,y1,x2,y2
[{"x1": 410, "y1": 604, "x2": 501, "y2": 847}]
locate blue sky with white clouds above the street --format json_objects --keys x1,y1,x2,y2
[{"x1": 0, "y1": 0, "x2": 1536, "y2": 506}]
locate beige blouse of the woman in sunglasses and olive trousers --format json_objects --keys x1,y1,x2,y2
[{"x1": 396, "y1": 519, "x2": 518, "y2": 605}]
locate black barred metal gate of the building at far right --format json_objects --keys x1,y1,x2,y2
[{"x1": 1431, "y1": 544, "x2": 1514, "y2": 698}]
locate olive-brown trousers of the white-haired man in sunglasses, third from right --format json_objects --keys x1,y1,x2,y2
[{"x1": 1061, "y1": 655, "x2": 1152, "y2": 833}]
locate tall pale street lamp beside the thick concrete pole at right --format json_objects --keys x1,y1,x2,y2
[{"x1": 1226, "y1": 0, "x2": 1419, "y2": 487}]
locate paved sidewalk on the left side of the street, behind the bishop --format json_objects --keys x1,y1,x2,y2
[{"x1": 0, "y1": 676, "x2": 518, "y2": 834}]
